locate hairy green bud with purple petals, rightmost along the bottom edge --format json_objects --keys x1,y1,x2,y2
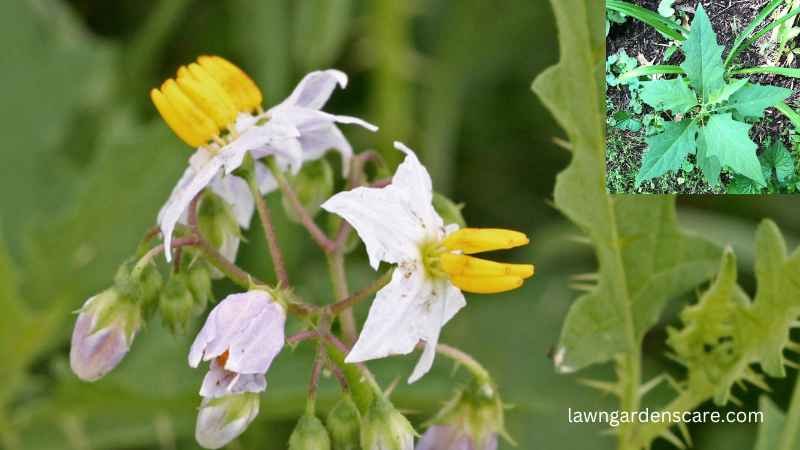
[{"x1": 416, "y1": 380, "x2": 506, "y2": 450}]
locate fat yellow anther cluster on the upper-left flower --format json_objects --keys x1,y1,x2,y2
[{"x1": 150, "y1": 56, "x2": 262, "y2": 147}]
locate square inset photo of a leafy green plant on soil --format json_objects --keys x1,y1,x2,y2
[{"x1": 605, "y1": 0, "x2": 800, "y2": 195}]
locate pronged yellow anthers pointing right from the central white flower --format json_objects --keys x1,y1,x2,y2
[{"x1": 438, "y1": 228, "x2": 534, "y2": 294}]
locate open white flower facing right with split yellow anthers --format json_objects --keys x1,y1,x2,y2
[{"x1": 322, "y1": 142, "x2": 533, "y2": 382}]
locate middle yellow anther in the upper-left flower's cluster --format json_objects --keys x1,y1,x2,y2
[{"x1": 177, "y1": 63, "x2": 237, "y2": 129}]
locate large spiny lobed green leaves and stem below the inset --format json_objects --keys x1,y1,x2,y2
[{"x1": 533, "y1": 0, "x2": 800, "y2": 450}]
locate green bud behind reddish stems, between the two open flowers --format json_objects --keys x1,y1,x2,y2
[{"x1": 282, "y1": 159, "x2": 334, "y2": 223}]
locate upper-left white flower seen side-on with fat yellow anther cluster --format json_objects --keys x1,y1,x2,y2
[{"x1": 151, "y1": 57, "x2": 377, "y2": 261}]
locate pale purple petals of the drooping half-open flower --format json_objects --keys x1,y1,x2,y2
[{"x1": 189, "y1": 290, "x2": 286, "y2": 374}]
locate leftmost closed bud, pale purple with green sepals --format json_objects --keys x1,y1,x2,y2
[{"x1": 69, "y1": 288, "x2": 142, "y2": 381}]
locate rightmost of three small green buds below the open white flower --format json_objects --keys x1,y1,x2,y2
[{"x1": 361, "y1": 397, "x2": 416, "y2": 450}]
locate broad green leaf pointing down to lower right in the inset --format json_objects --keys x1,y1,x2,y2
[{"x1": 699, "y1": 114, "x2": 767, "y2": 186}]
